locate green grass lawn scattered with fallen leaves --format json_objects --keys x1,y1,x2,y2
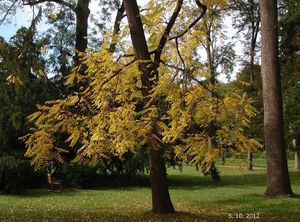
[{"x1": 0, "y1": 162, "x2": 300, "y2": 222}]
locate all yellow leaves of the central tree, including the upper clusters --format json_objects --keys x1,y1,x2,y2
[{"x1": 23, "y1": 2, "x2": 260, "y2": 173}]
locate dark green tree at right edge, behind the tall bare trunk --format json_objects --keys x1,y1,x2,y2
[{"x1": 279, "y1": 0, "x2": 300, "y2": 172}]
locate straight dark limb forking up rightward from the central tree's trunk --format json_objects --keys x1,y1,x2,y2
[{"x1": 154, "y1": 0, "x2": 183, "y2": 63}]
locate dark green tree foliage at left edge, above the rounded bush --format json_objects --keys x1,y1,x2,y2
[{"x1": 0, "y1": 25, "x2": 55, "y2": 154}]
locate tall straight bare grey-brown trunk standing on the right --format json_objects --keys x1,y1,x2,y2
[{"x1": 260, "y1": 0, "x2": 293, "y2": 197}]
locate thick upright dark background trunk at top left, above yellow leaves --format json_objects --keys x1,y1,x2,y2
[{"x1": 74, "y1": 0, "x2": 90, "y2": 65}]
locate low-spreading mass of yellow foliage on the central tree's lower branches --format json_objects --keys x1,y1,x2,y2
[{"x1": 25, "y1": 43, "x2": 259, "y2": 172}]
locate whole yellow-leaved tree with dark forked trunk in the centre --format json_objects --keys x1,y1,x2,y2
[{"x1": 24, "y1": 0, "x2": 260, "y2": 213}]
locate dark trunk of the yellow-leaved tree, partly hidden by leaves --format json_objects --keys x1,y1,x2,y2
[{"x1": 124, "y1": 0, "x2": 174, "y2": 213}]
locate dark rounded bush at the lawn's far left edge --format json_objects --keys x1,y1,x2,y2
[{"x1": 0, "y1": 156, "x2": 33, "y2": 194}]
